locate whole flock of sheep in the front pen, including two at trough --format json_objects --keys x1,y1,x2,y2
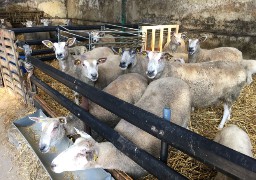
[{"x1": 15, "y1": 22, "x2": 256, "y2": 179}]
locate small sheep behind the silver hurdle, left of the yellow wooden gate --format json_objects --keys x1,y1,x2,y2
[{"x1": 90, "y1": 31, "x2": 115, "y2": 47}]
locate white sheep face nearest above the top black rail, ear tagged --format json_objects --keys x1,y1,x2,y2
[{"x1": 82, "y1": 58, "x2": 106, "y2": 81}]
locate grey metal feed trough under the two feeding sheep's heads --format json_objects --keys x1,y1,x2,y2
[{"x1": 13, "y1": 109, "x2": 113, "y2": 180}]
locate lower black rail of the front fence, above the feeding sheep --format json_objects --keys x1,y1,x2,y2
[{"x1": 31, "y1": 75, "x2": 186, "y2": 179}]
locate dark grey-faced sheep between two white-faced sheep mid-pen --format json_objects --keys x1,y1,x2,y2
[{"x1": 119, "y1": 48, "x2": 151, "y2": 78}]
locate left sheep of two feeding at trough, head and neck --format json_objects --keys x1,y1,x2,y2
[{"x1": 29, "y1": 114, "x2": 84, "y2": 153}]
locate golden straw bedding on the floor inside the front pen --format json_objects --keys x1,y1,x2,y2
[{"x1": 33, "y1": 60, "x2": 256, "y2": 179}]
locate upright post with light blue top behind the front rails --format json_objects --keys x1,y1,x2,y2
[{"x1": 160, "y1": 107, "x2": 171, "y2": 164}]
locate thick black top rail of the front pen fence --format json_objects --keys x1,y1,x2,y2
[{"x1": 28, "y1": 56, "x2": 256, "y2": 179}]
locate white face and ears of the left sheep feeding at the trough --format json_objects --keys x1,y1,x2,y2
[{"x1": 30, "y1": 117, "x2": 67, "y2": 153}]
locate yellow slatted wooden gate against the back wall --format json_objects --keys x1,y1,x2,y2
[{"x1": 141, "y1": 25, "x2": 179, "y2": 52}]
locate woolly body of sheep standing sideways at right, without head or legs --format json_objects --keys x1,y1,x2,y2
[{"x1": 166, "y1": 61, "x2": 247, "y2": 107}]
